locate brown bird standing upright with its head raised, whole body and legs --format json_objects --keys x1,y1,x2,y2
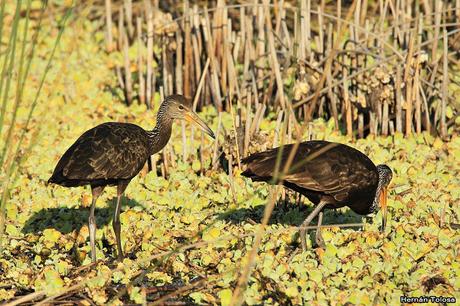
[{"x1": 48, "y1": 95, "x2": 215, "y2": 262}]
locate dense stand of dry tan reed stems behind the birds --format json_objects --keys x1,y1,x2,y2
[{"x1": 101, "y1": 0, "x2": 460, "y2": 147}]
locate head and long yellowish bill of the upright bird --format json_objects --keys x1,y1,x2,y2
[{"x1": 158, "y1": 95, "x2": 216, "y2": 138}]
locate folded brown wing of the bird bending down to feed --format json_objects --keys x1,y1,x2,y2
[{"x1": 243, "y1": 141, "x2": 378, "y2": 201}]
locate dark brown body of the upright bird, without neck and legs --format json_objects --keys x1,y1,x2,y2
[{"x1": 49, "y1": 122, "x2": 150, "y2": 186}]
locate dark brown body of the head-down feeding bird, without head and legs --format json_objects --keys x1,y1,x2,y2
[{"x1": 242, "y1": 140, "x2": 378, "y2": 214}]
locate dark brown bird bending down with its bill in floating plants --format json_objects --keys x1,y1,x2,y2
[{"x1": 242, "y1": 140, "x2": 393, "y2": 249}]
